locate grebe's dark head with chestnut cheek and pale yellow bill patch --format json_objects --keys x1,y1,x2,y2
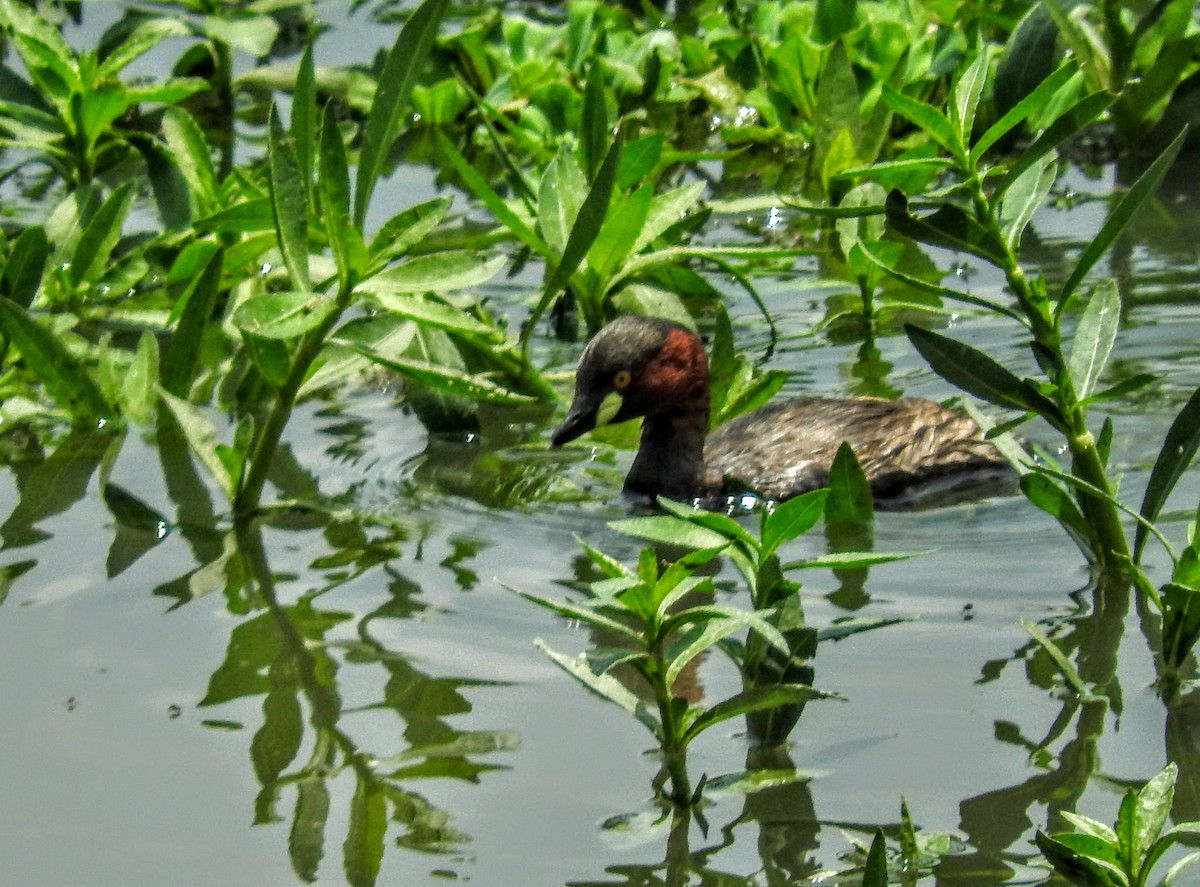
[{"x1": 550, "y1": 317, "x2": 708, "y2": 447}]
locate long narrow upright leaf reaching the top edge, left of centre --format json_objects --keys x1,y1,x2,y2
[{"x1": 354, "y1": 0, "x2": 446, "y2": 230}]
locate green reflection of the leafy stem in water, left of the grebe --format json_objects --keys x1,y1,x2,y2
[{"x1": 191, "y1": 523, "x2": 518, "y2": 887}]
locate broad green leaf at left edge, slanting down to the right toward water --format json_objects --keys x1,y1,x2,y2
[{"x1": 0, "y1": 299, "x2": 113, "y2": 424}]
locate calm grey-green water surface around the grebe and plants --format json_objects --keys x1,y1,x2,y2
[{"x1": 0, "y1": 6, "x2": 1200, "y2": 887}]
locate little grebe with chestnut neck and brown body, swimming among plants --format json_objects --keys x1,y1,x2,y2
[{"x1": 551, "y1": 317, "x2": 1008, "y2": 504}]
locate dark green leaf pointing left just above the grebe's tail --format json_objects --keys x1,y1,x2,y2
[{"x1": 905, "y1": 324, "x2": 1066, "y2": 430}]
